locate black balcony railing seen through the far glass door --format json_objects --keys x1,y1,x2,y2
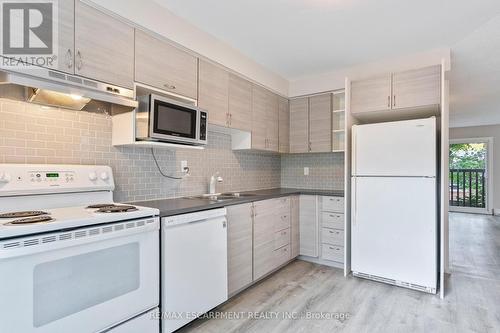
[{"x1": 449, "y1": 169, "x2": 486, "y2": 208}]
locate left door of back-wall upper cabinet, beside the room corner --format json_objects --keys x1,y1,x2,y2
[{"x1": 290, "y1": 97, "x2": 309, "y2": 153}]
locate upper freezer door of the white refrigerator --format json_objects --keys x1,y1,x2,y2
[{"x1": 352, "y1": 117, "x2": 436, "y2": 176}]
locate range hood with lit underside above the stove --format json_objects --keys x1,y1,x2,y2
[{"x1": 0, "y1": 66, "x2": 138, "y2": 113}]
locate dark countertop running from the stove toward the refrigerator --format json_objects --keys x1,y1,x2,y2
[{"x1": 131, "y1": 188, "x2": 344, "y2": 217}]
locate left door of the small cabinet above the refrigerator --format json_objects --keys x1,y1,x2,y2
[{"x1": 351, "y1": 74, "x2": 392, "y2": 114}]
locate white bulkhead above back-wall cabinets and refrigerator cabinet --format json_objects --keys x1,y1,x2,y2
[{"x1": 289, "y1": 48, "x2": 450, "y2": 97}]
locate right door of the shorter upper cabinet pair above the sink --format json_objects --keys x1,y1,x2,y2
[{"x1": 229, "y1": 74, "x2": 252, "y2": 132}]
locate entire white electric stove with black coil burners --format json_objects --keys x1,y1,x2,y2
[{"x1": 0, "y1": 164, "x2": 160, "y2": 333}]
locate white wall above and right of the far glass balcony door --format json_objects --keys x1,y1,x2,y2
[{"x1": 450, "y1": 125, "x2": 500, "y2": 214}]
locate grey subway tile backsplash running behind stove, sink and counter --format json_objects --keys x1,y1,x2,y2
[{"x1": 0, "y1": 99, "x2": 343, "y2": 202}]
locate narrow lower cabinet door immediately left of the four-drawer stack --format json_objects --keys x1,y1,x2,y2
[{"x1": 299, "y1": 195, "x2": 319, "y2": 258}]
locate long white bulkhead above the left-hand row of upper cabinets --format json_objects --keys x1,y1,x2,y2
[{"x1": 84, "y1": 0, "x2": 288, "y2": 96}]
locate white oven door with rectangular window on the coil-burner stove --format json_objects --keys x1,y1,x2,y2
[{"x1": 0, "y1": 218, "x2": 159, "y2": 333}]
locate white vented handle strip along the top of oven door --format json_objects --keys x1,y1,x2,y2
[{"x1": 0, "y1": 218, "x2": 160, "y2": 260}]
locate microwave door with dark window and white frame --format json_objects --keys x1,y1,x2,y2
[{"x1": 149, "y1": 95, "x2": 200, "y2": 144}]
